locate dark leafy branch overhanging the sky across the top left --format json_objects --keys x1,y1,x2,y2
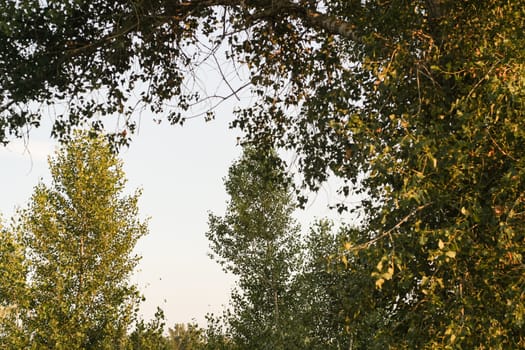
[{"x1": 0, "y1": 0, "x2": 361, "y2": 143}]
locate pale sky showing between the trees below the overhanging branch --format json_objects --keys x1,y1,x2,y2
[{"x1": 0, "y1": 109, "x2": 344, "y2": 326}]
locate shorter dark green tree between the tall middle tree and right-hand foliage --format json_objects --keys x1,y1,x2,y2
[{"x1": 297, "y1": 220, "x2": 402, "y2": 350}]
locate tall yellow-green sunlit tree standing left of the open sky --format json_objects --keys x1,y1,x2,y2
[{"x1": 19, "y1": 134, "x2": 147, "y2": 349}]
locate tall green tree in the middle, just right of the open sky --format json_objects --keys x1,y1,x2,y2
[{"x1": 206, "y1": 148, "x2": 301, "y2": 349}]
